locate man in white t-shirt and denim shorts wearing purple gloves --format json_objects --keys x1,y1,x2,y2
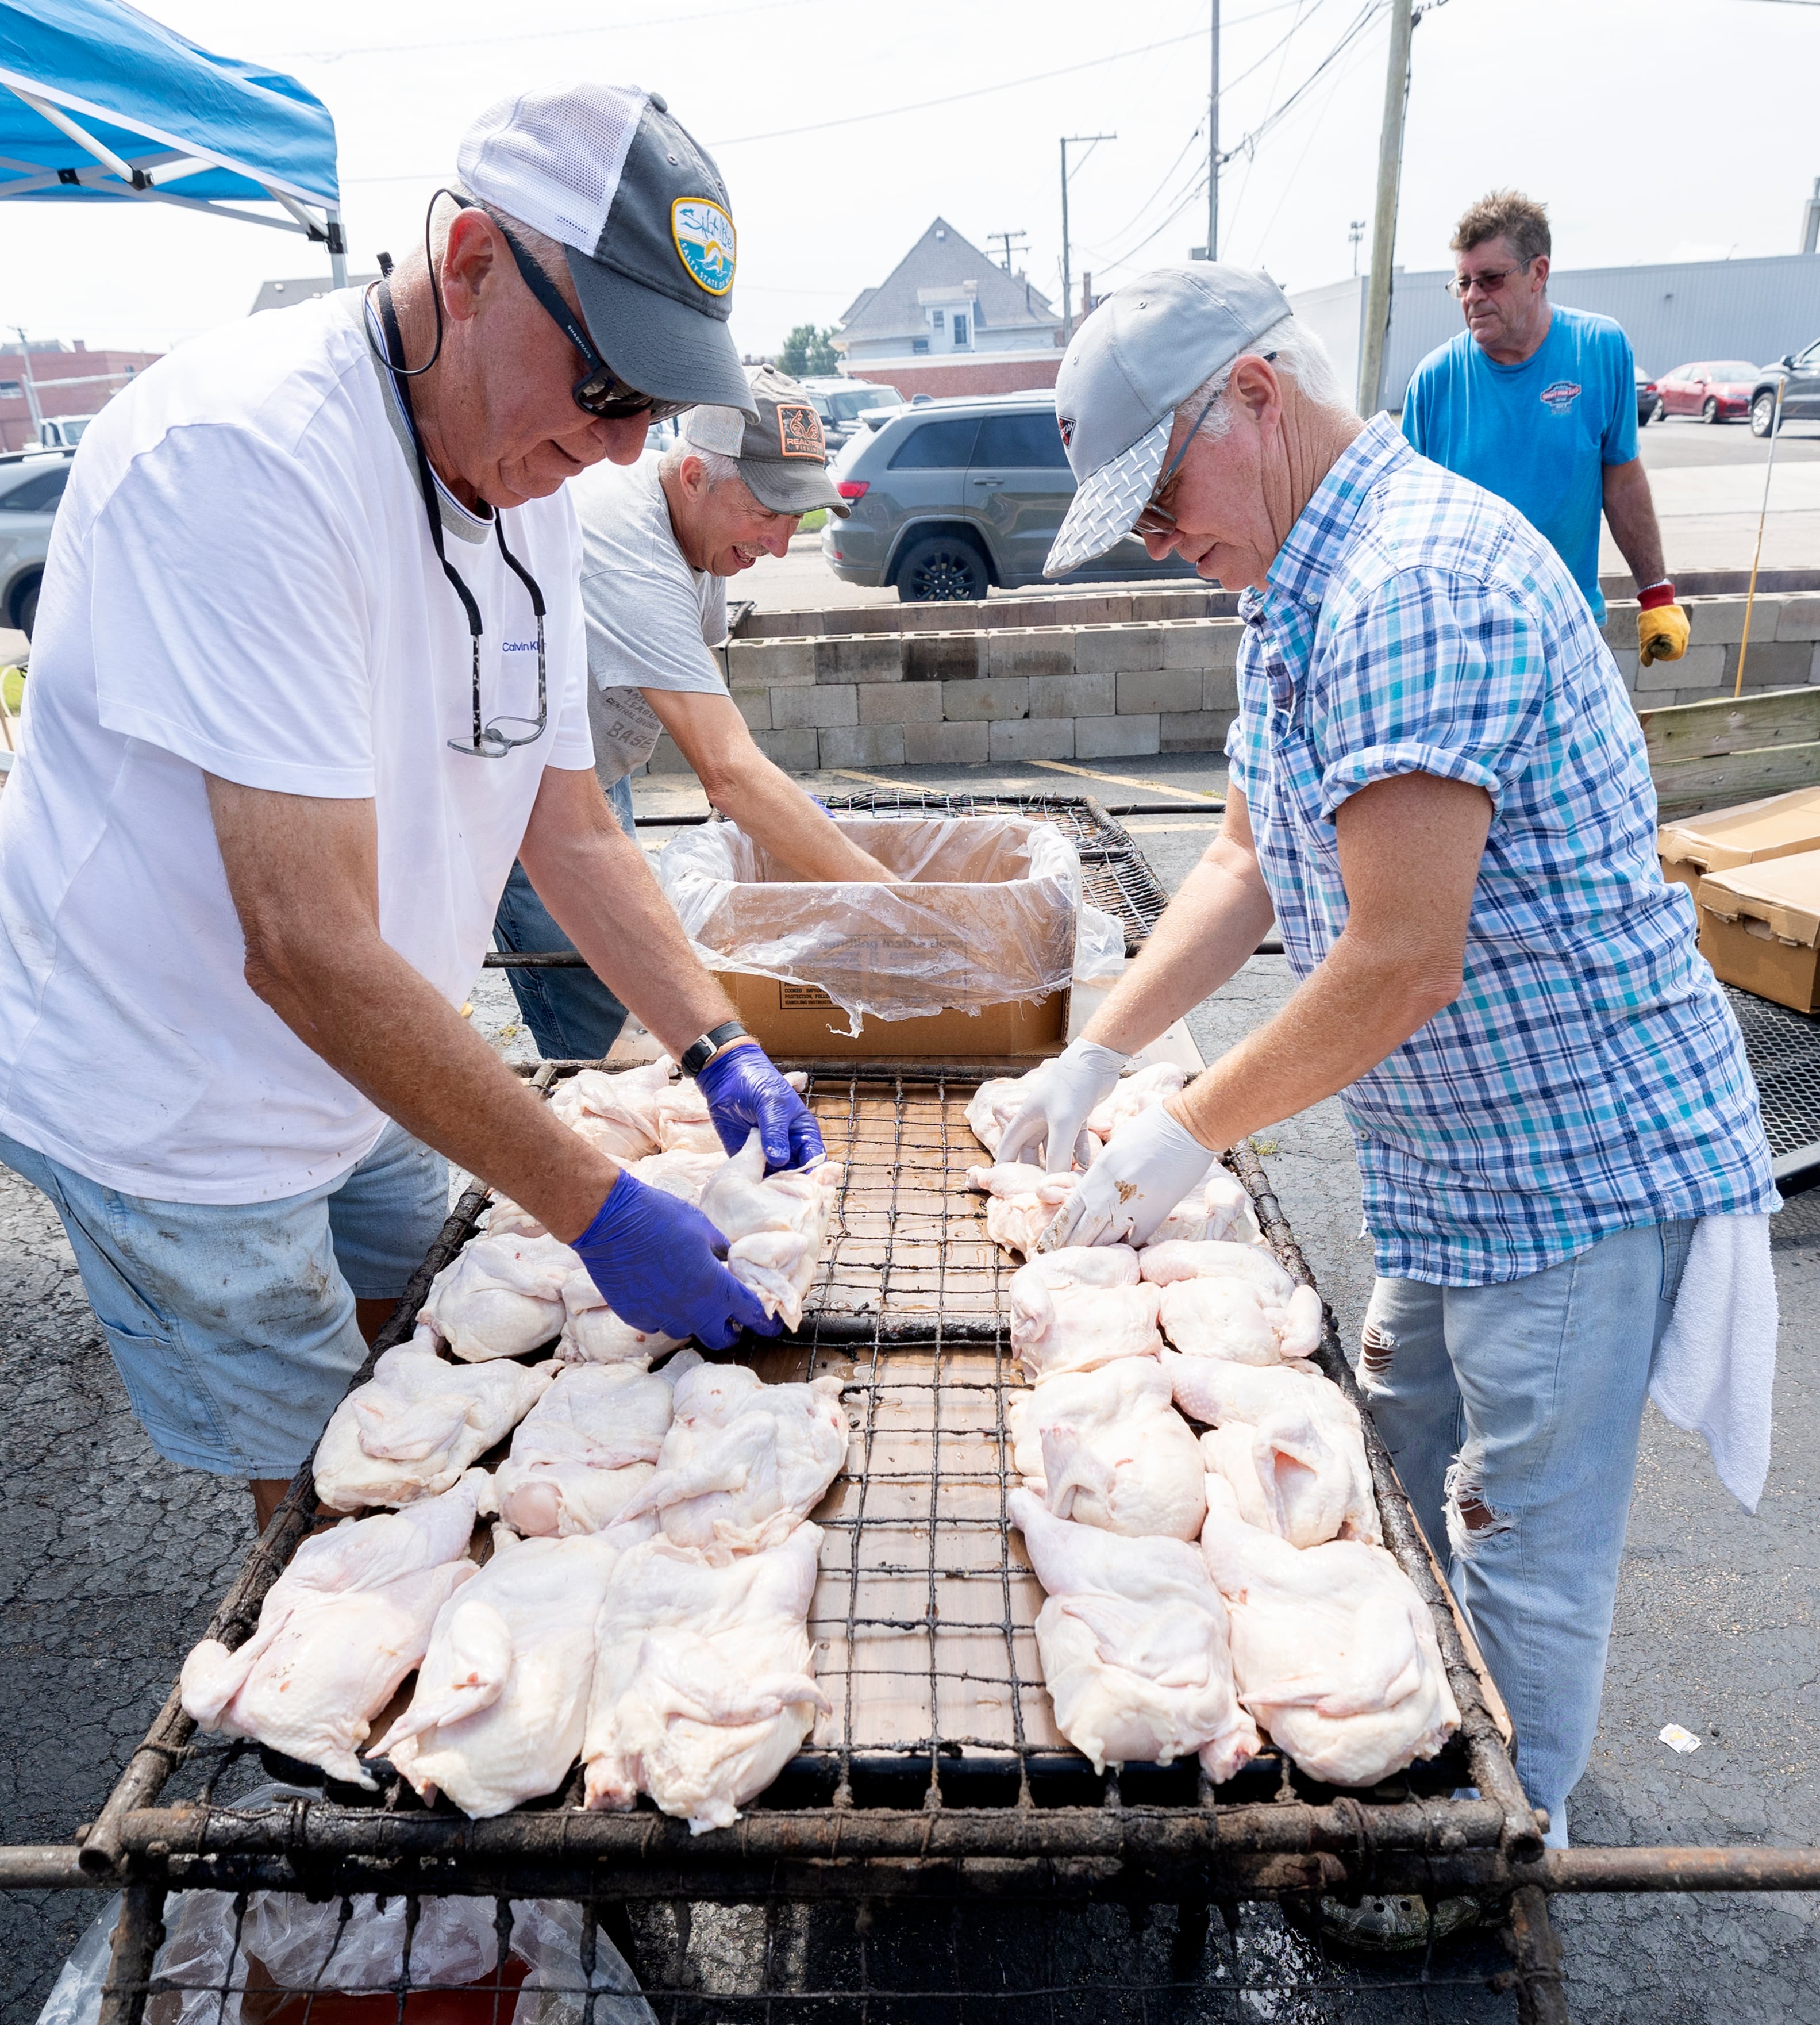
[{"x1": 0, "y1": 85, "x2": 820, "y2": 1517}]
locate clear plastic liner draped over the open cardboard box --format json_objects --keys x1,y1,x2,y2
[{"x1": 658, "y1": 816, "x2": 1123, "y2": 1031}]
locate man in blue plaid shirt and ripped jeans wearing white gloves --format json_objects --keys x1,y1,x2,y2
[{"x1": 998, "y1": 266, "x2": 1777, "y2": 1845}]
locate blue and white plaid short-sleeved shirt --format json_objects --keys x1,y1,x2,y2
[{"x1": 1227, "y1": 415, "x2": 1777, "y2": 1286}]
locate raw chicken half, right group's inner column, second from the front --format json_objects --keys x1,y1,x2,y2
[{"x1": 1008, "y1": 1361, "x2": 1207, "y2": 1539}]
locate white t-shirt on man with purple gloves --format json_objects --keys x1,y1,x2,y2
[{"x1": 0, "y1": 290, "x2": 593, "y2": 1203}]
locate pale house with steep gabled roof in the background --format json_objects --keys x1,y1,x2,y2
[{"x1": 834, "y1": 218, "x2": 1061, "y2": 399}]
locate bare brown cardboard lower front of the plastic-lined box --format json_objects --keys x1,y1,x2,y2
[{"x1": 715, "y1": 970, "x2": 1069, "y2": 1065}]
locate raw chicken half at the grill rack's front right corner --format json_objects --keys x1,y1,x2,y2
[{"x1": 1200, "y1": 1476, "x2": 1460, "y2": 1786}]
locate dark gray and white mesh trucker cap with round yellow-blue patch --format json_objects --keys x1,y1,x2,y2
[{"x1": 470, "y1": 85, "x2": 753, "y2": 413}]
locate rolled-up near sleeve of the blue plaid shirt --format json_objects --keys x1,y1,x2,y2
[{"x1": 1308, "y1": 569, "x2": 1546, "y2": 822}]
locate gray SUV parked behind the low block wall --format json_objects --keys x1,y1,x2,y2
[{"x1": 822, "y1": 393, "x2": 1194, "y2": 601}]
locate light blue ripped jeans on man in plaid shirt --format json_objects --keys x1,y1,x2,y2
[{"x1": 1359, "y1": 1221, "x2": 1695, "y2": 1849}]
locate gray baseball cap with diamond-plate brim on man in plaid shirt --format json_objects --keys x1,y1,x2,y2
[{"x1": 1042, "y1": 261, "x2": 1290, "y2": 577}]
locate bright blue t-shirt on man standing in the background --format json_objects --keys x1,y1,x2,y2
[{"x1": 1403, "y1": 310, "x2": 1636, "y2": 626}]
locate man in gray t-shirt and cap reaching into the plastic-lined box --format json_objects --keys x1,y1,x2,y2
[{"x1": 494, "y1": 367, "x2": 891, "y2": 1061}]
